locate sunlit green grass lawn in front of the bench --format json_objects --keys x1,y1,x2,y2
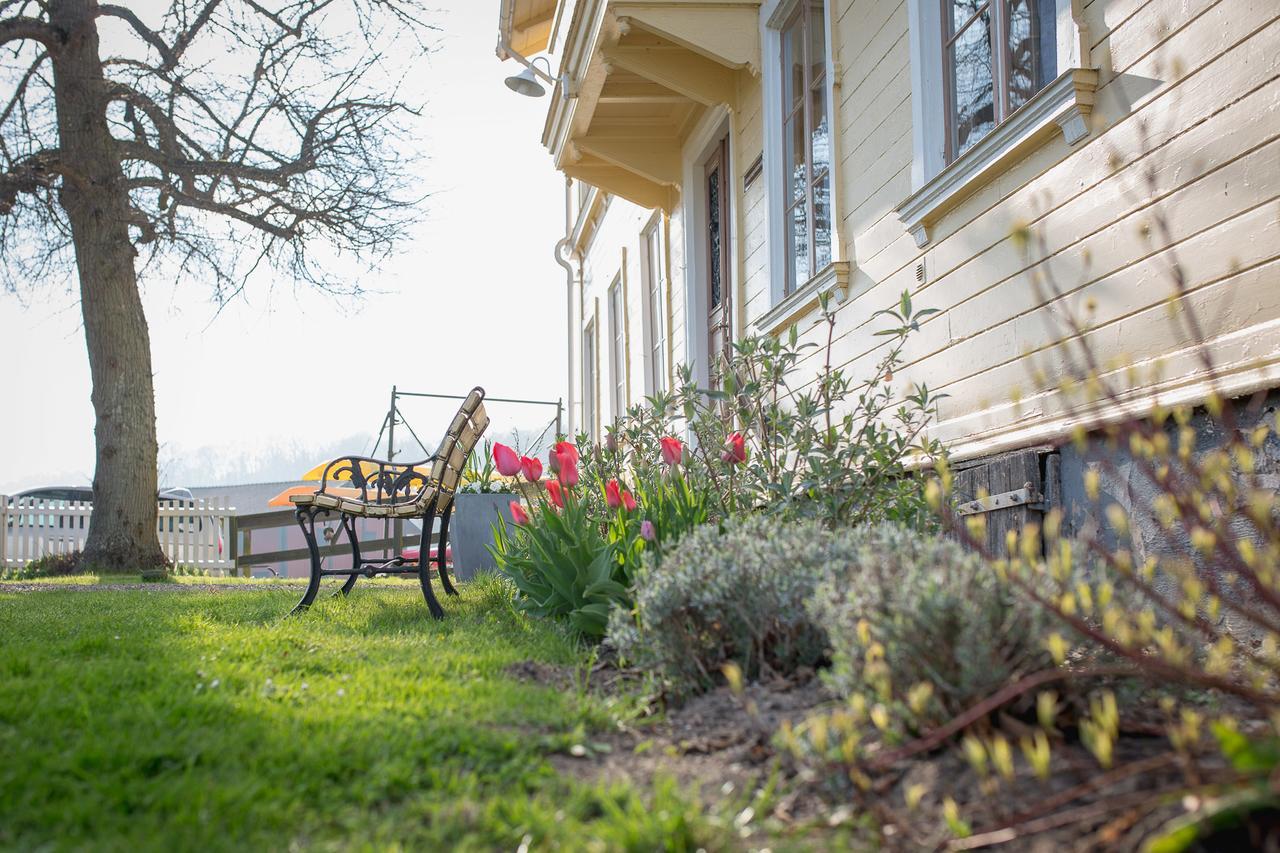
[{"x1": 0, "y1": 579, "x2": 731, "y2": 850}]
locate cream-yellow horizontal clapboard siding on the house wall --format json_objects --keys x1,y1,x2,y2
[{"x1": 552, "y1": 0, "x2": 1280, "y2": 455}]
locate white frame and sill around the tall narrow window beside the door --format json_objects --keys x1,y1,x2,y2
[{"x1": 755, "y1": 0, "x2": 847, "y2": 322}]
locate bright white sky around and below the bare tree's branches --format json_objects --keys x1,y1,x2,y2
[{"x1": 0, "y1": 0, "x2": 564, "y2": 493}]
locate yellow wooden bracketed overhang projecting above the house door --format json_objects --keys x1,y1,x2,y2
[{"x1": 540, "y1": 0, "x2": 760, "y2": 211}]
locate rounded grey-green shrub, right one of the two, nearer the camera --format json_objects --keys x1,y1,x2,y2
[{"x1": 808, "y1": 524, "x2": 1053, "y2": 727}]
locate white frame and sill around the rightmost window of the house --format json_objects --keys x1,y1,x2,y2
[{"x1": 897, "y1": 0, "x2": 1097, "y2": 247}]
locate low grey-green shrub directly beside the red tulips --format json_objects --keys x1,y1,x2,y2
[{"x1": 608, "y1": 515, "x2": 851, "y2": 695}]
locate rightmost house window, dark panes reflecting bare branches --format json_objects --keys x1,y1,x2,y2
[{"x1": 938, "y1": 0, "x2": 1057, "y2": 163}]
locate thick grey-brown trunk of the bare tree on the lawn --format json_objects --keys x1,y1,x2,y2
[{"x1": 50, "y1": 0, "x2": 168, "y2": 571}]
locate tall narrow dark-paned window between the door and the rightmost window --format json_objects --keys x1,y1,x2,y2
[{"x1": 780, "y1": 0, "x2": 831, "y2": 295}]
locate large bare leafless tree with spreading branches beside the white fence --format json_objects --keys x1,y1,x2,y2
[{"x1": 0, "y1": 0, "x2": 426, "y2": 570}]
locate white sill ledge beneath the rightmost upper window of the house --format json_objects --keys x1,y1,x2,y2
[{"x1": 896, "y1": 68, "x2": 1098, "y2": 247}]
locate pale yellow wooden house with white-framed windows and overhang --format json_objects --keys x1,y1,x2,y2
[{"x1": 498, "y1": 0, "x2": 1280, "y2": 525}]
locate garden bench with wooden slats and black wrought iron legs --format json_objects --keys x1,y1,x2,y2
[{"x1": 289, "y1": 387, "x2": 489, "y2": 619}]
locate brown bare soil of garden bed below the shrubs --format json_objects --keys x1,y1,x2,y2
[{"x1": 511, "y1": 662, "x2": 1240, "y2": 853}]
